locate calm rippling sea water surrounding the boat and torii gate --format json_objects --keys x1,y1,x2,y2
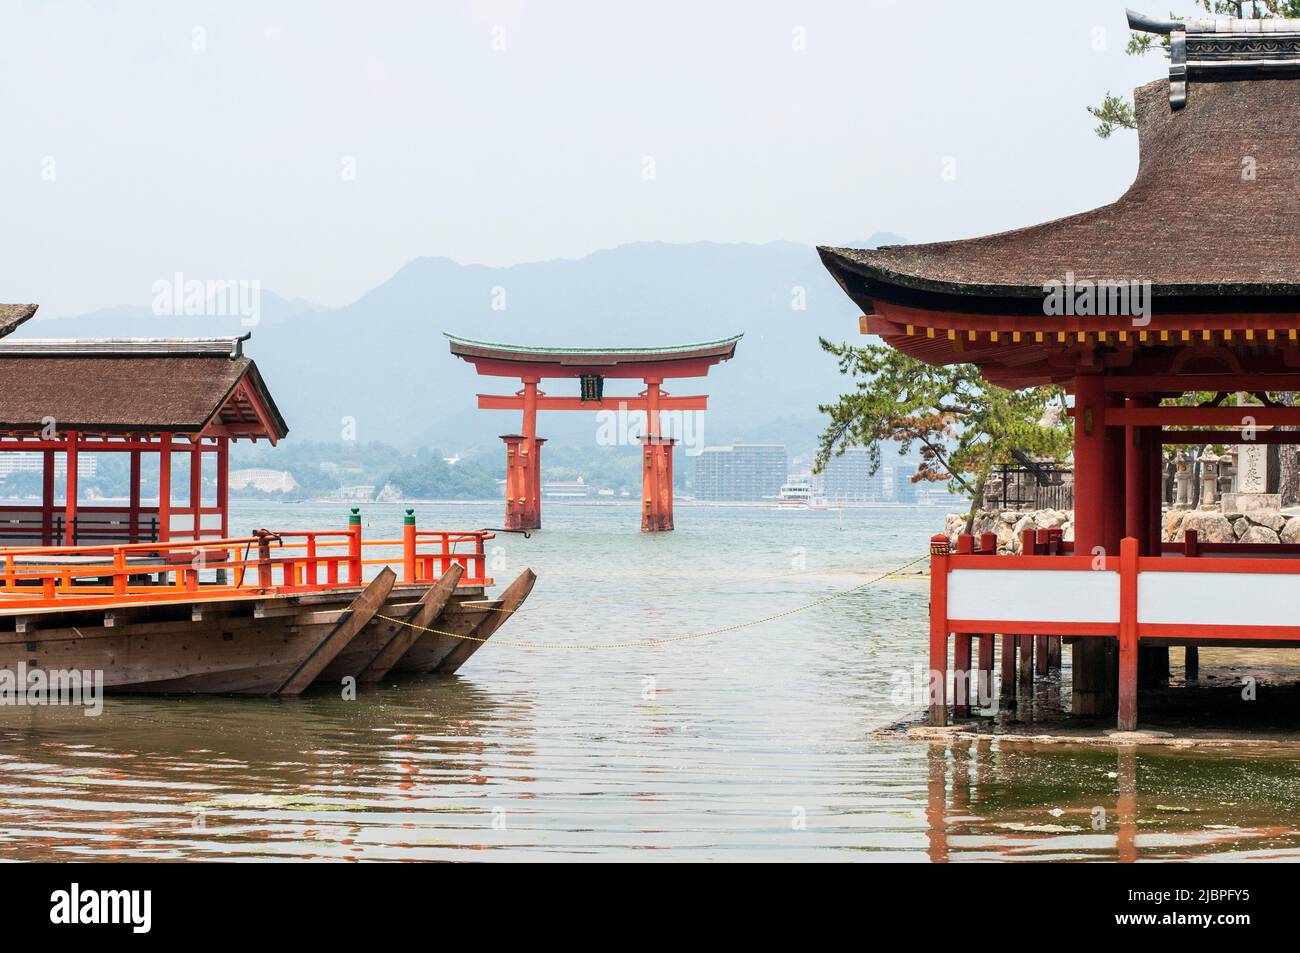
[{"x1": 0, "y1": 504, "x2": 1300, "y2": 861}]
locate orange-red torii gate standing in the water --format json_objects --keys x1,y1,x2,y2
[{"x1": 446, "y1": 334, "x2": 742, "y2": 533}]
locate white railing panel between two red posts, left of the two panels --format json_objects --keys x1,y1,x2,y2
[{"x1": 948, "y1": 569, "x2": 1119, "y2": 623}]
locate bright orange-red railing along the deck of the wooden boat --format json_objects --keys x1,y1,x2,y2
[{"x1": 0, "y1": 508, "x2": 495, "y2": 614}]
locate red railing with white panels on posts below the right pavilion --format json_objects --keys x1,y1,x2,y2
[{"x1": 928, "y1": 530, "x2": 1300, "y2": 729}]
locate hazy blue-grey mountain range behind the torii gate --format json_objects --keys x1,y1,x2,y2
[{"x1": 16, "y1": 234, "x2": 902, "y2": 454}]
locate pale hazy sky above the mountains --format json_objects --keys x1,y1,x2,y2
[{"x1": 0, "y1": 0, "x2": 1170, "y2": 315}]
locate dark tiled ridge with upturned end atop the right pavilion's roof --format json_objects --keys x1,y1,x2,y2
[{"x1": 1126, "y1": 10, "x2": 1300, "y2": 109}]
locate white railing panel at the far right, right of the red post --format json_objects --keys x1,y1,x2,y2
[{"x1": 1138, "y1": 572, "x2": 1300, "y2": 625}]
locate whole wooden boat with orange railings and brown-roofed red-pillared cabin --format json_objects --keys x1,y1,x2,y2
[{"x1": 0, "y1": 306, "x2": 536, "y2": 696}]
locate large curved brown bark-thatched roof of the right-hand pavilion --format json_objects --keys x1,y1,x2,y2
[{"x1": 819, "y1": 79, "x2": 1300, "y2": 316}]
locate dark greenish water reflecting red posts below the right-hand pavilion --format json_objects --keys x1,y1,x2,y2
[{"x1": 926, "y1": 737, "x2": 1300, "y2": 863}]
